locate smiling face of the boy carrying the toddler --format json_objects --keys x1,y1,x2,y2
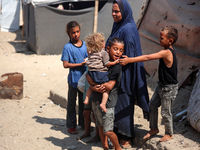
[{"x1": 107, "y1": 43, "x2": 124, "y2": 61}]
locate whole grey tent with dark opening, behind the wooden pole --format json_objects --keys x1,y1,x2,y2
[{"x1": 23, "y1": 0, "x2": 145, "y2": 54}]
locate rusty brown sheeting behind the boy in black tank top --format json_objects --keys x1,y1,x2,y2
[{"x1": 139, "y1": 0, "x2": 200, "y2": 85}]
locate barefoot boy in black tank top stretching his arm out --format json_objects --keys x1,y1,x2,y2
[{"x1": 119, "y1": 26, "x2": 178, "y2": 142}]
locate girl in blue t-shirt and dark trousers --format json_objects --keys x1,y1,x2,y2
[{"x1": 61, "y1": 21, "x2": 88, "y2": 134}]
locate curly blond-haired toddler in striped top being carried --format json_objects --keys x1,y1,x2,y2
[{"x1": 84, "y1": 33, "x2": 118, "y2": 112}]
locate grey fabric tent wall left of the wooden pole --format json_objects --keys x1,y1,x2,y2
[{"x1": 23, "y1": 3, "x2": 94, "y2": 55}]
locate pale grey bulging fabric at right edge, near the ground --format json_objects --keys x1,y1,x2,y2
[{"x1": 187, "y1": 70, "x2": 200, "y2": 132}]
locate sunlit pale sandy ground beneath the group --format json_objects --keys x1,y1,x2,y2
[{"x1": 0, "y1": 30, "x2": 200, "y2": 150}]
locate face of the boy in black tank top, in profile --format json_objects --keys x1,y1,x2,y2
[{"x1": 159, "y1": 31, "x2": 172, "y2": 48}]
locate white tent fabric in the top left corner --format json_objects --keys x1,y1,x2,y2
[{"x1": 1, "y1": 0, "x2": 20, "y2": 32}]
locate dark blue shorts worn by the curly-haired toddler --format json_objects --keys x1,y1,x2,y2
[{"x1": 88, "y1": 71, "x2": 109, "y2": 84}]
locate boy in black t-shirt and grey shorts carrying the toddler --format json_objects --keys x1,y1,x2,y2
[{"x1": 86, "y1": 37, "x2": 124, "y2": 150}]
